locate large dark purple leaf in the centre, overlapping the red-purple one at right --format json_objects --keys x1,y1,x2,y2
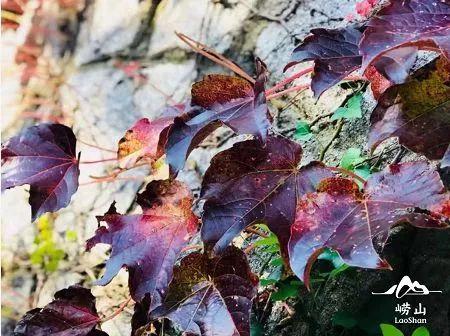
[{"x1": 201, "y1": 136, "x2": 333, "y2": 253}]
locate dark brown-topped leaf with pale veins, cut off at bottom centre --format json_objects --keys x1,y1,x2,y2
[{"x1": 151, "y1": 247, "x2": 258, "y2": 336}]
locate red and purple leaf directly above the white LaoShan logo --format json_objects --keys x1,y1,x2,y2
[{"x1": 289, "y1": 161, "x2": 450, "y2": 286}]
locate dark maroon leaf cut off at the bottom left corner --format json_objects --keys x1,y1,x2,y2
[{"x1": 14, "y1": 286, "x2": 106, "y2": 336}]
